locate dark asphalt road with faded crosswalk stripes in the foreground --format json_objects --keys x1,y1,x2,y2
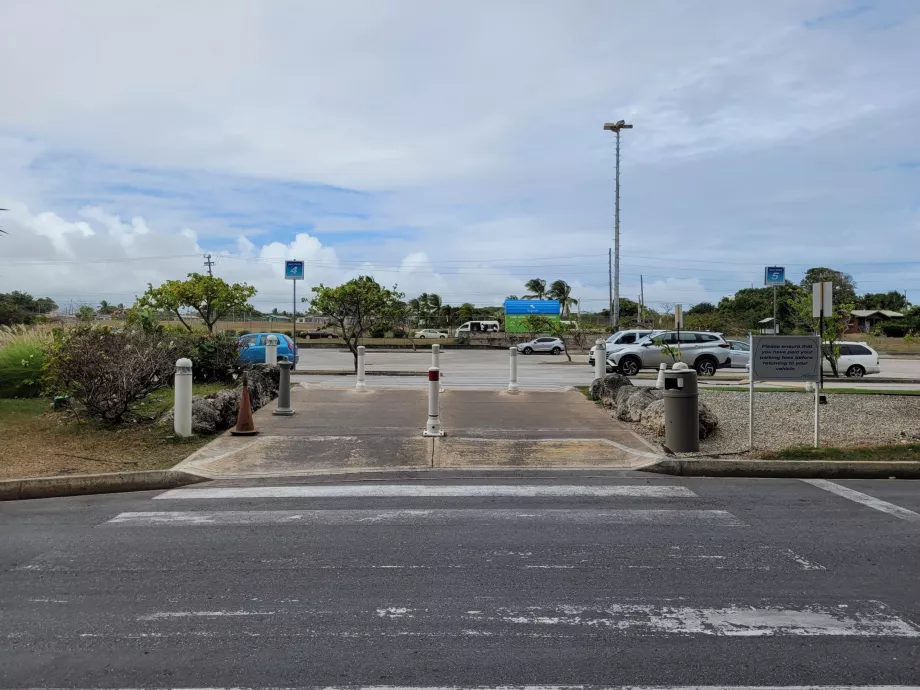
[{"x1": 0, "y1": 472, "x2": 920, "y2": 688}]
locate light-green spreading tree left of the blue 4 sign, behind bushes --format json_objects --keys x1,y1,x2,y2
[{"x1": 135, "y1": 273, "x2": 256, "y2": 333}]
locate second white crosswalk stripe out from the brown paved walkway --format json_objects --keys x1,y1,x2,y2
[{"x1": 106, "y1": 508, "x2": 747, "y2": 527}]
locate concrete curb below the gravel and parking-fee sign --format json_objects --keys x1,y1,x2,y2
[{"x1": 642, "y1": 458, "x2": 920, "y2": 479}]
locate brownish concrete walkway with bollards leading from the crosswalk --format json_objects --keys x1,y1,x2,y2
[{"x1": 176, "y1": 387, "x2": 660, "y2": 478}]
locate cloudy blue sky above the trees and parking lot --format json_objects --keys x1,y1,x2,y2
[{"x1": 0, "y1": 0, "x2": 920, "y2": 311}]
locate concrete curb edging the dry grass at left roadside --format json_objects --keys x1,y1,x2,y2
[{"x1": 0, "y1": 470, "x2": 208, "y2": 501}]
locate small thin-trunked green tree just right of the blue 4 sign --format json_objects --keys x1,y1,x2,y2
[{"x1": 303, "y1": 276, "x2": 405, "y2": 371}]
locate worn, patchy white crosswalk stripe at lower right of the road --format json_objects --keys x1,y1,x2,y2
[{"x1": 467, "y1": 601, "x2": 920, "y2": 637}]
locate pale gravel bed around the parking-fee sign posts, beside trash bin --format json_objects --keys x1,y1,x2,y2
[{"x1": 688, "y1": 390, "x2": 920, "y2": 453}]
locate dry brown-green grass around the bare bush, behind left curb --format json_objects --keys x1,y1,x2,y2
[{"x1": 0, "y1": 384, "x2": 227, "y2": 480}]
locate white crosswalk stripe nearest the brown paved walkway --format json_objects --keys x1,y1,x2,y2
[{"x1": 154, "y1": 484, "x2": 696, "y2": 499}]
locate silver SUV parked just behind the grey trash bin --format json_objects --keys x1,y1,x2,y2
[{"x1": 607, "y1": 331, "x2": 731, "y2": 376}]
